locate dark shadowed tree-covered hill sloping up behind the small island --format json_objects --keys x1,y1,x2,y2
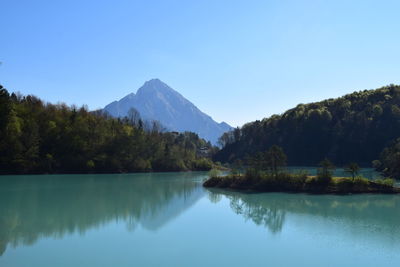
[{"x1": 214, "y1": 85, "x2": 400, "y2": 166}]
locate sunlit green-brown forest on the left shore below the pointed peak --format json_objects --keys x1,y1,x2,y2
[{"x1": 0, "y1": 85, "x2": 216, "y2": 174}]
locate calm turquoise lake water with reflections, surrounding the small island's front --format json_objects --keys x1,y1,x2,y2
[{"x1": 0, "y1": 173, "x2": 400, "y2": 267}]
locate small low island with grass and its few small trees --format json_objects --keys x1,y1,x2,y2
[{"x1": 203, "y1": 146, "x2": 400, "y2": 194}]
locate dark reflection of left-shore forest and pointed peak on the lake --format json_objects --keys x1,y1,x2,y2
[{"x1": 0, "y1": 173, "x2": 204, "y2": 255}]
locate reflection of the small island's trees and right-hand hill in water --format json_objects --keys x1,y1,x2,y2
[{"x1": 209, "y1": 189, "x2": 400, "y2": 238}]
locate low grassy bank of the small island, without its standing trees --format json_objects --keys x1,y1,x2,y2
[{"x1": 204, "y1": 169, "x2": 400, "y2": 194}]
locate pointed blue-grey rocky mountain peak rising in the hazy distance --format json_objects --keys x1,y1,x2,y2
[{"x1": 104, "y1": 79, "x2": 232, "y2": 144}]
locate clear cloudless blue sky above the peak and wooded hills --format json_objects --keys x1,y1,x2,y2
[{"x1": 0, "y1": 0, "x2": 400, "y2": 126}]
